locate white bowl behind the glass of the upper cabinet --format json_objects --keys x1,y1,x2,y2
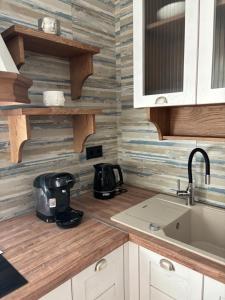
[{"x1": 157, "y1": 1, "x2": 185, "y2": 20}]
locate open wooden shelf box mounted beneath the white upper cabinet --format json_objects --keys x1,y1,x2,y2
[{"x1": 149, "y1": 104, "x2": 225, "y2": 142}]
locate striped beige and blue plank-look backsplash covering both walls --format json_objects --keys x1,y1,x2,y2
[{"x1": 0, "y1": 0, "x2": 225, "y2": 219}]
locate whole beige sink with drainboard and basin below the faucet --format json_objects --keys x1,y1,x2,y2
[{"x1": 112, "y1": 194, "x2": 225, "y2": 265}]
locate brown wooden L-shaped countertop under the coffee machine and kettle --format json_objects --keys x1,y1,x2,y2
[{"x1": 0, "y1": 186, "x2": 225, "y2": 300}]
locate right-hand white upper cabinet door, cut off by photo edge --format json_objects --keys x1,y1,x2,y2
[{"x1": 197, "y1": 0, "x2": 225, "y2": 104}]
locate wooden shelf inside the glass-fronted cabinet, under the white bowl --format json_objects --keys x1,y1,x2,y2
[{"x1": 147, "y1": 14, "x2": 185, "y2": 31}]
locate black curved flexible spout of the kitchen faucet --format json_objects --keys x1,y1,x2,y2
[{"x1": 188, "y1": 148, "x2": 210, "y2": 184}]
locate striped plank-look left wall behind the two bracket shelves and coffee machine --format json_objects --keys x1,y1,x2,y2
[{"x1": 0, "y1": 0, "x2": 118, "y2": 220}]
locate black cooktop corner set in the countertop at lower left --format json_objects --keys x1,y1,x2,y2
[{"x1": 0, "y1": 255, "x2": 28, "y2": 298}]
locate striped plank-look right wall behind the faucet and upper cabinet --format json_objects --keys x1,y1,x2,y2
[{"x1": 116, "y1": 0, "x2": 225, "y2": 205}]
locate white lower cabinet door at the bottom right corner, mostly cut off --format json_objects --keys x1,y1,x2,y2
[{"x1": 203, "y1": 276, "x2": 225, "y2": 300}]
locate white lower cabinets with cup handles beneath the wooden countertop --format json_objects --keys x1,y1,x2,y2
[{"x1": 40, "y1": 242, "x2": 225, "y2": 300}]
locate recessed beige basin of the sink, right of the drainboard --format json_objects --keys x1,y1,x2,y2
[{"x1": 163, "y1": 205, "x2": 225, "y2": 259}]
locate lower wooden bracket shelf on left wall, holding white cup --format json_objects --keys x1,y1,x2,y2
[{"x1": 0, "y1": 107, "x2": 101, "y2": 163}]
